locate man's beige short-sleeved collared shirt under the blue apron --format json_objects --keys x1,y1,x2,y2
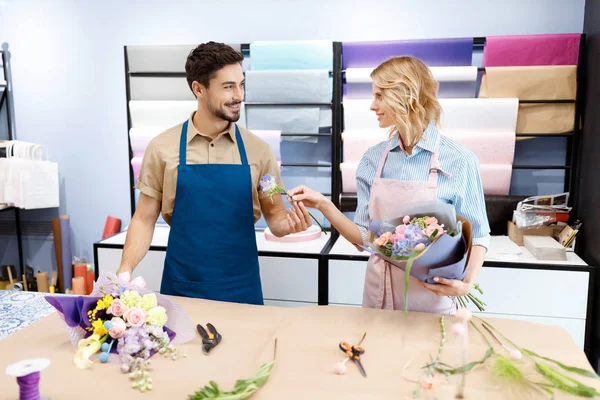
[{"x1": 136, "y1": 112, "x2": 281, "y2": 225}]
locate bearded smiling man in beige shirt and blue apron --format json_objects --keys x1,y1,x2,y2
[{"x1": 118, "y1": 42, "x2": 311, "y2": 304}]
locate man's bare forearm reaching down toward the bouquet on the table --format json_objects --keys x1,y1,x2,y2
[{"x1": 118, "y1": 216, "x2": 154, "y2": 273}]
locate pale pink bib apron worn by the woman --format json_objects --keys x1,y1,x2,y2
[{"x1": 363, "y1": 136, "x2": 457, "y2": 314}]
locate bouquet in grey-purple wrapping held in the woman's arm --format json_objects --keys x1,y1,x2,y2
[{"x1": 360, "y1": 201, "x2": 485, "y2": 311}]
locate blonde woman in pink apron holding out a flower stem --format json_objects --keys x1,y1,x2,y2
[{"x1": 290, "y1": 57, "x2": 490, "y2": 314}]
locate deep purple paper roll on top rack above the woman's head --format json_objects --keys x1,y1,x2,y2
[{"x1": 342, "y1": 38, "x2": 473, "y2": 69}]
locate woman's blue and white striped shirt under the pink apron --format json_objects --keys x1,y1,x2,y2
[{"x1": 354, "y1": 123, "x2": 490, "y2": 249}]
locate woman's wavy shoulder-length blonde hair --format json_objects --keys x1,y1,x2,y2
[{"x1": 371, "y1": 56, "x2": 442, "y2": 147}]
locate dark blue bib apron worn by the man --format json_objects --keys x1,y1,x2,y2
[{"x1": 160, "y1": 121, "x2": 263, "y2": 305}]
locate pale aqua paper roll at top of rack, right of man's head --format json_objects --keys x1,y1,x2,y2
[{"x1": 250, "y1": 40, "x2": 333, "y2": 71}]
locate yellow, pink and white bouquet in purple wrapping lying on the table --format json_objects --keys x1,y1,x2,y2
[{"x1": 46, "y1": 273, "x2": 195, "y2": 391}]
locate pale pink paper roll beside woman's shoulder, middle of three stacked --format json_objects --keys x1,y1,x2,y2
[{"x1": 443, "y1": 130, "x2": 515, "y2": 164}]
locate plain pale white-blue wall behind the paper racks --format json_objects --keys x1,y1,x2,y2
[{"x1": 0, "y1": 0, "x2": 584, "y2": 268}]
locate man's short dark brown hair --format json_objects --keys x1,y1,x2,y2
[{"x1": 185, "y1": 42, "x2": 244, "y2": 94}]
